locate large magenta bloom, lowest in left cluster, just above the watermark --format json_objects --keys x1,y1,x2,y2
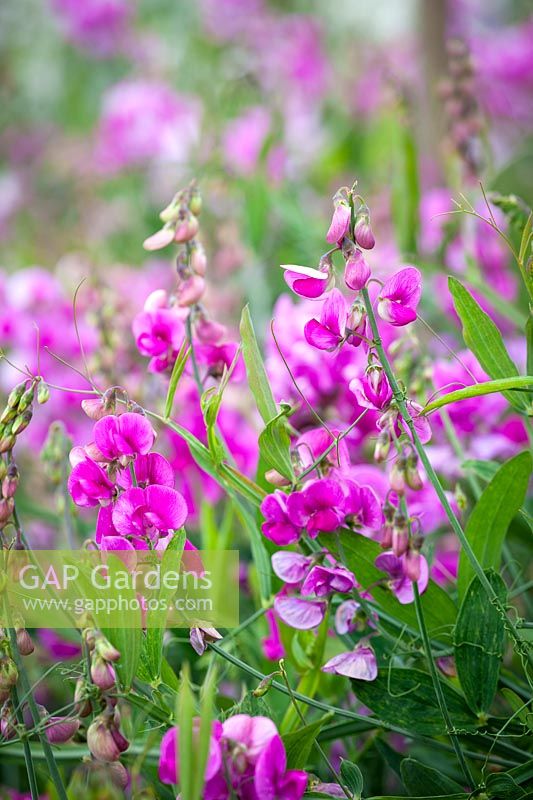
[{"x1": 111, "y1": 486, "x2": 188, "y2": 546}]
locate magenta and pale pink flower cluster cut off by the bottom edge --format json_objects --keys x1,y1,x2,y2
[{"x1": 159, "y1": 714, "x2": 307, "y2": 800}]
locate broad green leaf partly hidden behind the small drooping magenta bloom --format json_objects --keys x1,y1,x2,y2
[{"x1": 319, "y1": 531, "x2": 457, "y2": 639}]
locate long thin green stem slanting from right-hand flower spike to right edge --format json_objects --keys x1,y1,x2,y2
[{"x1": 362, "y1": 288, "x2": 533, "y2": 664}]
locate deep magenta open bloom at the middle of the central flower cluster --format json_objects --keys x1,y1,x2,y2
[{"x1": 287, "y1": 478, "x2": 344, "y2": 538}]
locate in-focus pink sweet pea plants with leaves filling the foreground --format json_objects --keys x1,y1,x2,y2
[{"x1": 0, "y1": 178, "x2": 533, "y2": 800}]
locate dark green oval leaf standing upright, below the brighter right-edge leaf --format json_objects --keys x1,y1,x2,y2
[{"x1": 454, "y1": 570, "x2": 507, "y2": 717}]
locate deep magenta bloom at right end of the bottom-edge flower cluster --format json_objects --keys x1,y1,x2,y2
[{"x1": 254, "y1": 735, "x2": 307, "y2": 800}]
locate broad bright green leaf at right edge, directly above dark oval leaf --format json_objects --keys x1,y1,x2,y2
[{"x1": 457, "y1": 452, "x2": 531, "y2": 598}]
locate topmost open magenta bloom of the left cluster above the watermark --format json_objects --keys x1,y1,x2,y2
[{"x1": 94, "y1": 412, "x2": 155, "y2": 461}]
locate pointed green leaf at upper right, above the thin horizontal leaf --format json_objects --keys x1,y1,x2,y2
[{"x1": 448, "y1": 277, "x2": 531, "y2": 413}]
